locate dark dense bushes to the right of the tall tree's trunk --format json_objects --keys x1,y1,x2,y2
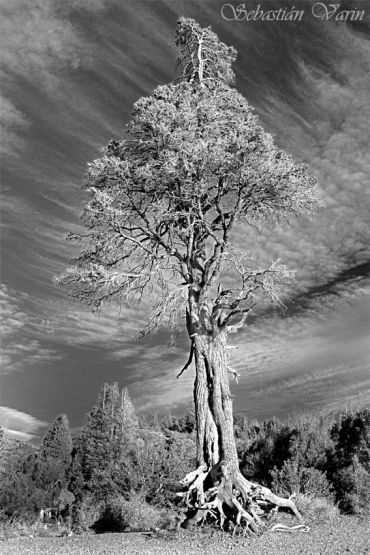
[{"x1": 236, "y1": 408, "x2": 370, "y2": 513}]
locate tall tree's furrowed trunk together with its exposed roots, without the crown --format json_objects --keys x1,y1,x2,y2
[{"x1": 179, "y1": 331, "x2": 302, "y2": 532}]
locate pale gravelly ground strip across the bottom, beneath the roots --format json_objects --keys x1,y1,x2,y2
[{"x1": 0, "y1": 517, "x2": 370, "y2": 555}]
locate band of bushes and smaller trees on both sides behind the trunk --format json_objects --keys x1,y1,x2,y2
[{"x1": 0, "y1": 384, "x2": 370, "y2": 532}]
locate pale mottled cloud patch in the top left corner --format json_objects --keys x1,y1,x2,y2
[{"x1": 0, "y1": 0, "x2": 80, "y2": 154}]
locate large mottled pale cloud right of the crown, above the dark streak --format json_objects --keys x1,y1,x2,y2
[{"x1": 227, "y1": 21, "x2": 370, "y2": 326}]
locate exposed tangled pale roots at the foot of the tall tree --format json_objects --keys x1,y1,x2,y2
[{"x1": 178, "y1": 461, "x2": 308, "y2": 535}]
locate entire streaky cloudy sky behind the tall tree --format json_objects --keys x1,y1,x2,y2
[{"x1": 0, "y1": 0, "x2": 370, "y2": 442}]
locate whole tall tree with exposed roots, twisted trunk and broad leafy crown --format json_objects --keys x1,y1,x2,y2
[{"x1": 58, "y1": 18, "x2": 317, "y2": 529}]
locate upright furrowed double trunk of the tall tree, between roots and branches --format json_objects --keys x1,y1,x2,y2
[{"x1": 194, "y1": 332, "x2": 238, "y2": 472}]
